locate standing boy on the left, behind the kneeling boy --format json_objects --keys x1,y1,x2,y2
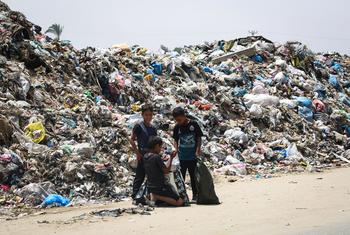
[{"x1": 130, "y1": 104, "x2": 157, "y2": 199}]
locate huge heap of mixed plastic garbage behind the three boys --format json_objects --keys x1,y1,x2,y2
[{"x1": 0, "y1": 1, "x2": 350, "y2": 206}]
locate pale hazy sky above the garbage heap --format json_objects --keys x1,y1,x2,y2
[{"x1": 2, "y1": 0, "x2": 350, "y2": 54}]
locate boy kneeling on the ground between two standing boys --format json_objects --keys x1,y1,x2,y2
[{"x1": 144, "y1": 136, "x2": 184, "y2": 206}]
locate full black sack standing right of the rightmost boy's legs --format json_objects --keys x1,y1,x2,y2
[{"x1": 195, "y1": 160, "x2": 220, "y2": 205}]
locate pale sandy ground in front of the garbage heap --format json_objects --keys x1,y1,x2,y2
[{"x1": 0, "y1": 168, "x2": 350, "y2": 235}]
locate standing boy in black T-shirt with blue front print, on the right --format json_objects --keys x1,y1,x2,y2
[{"x1": 173, "y1": 107, "x2": 203, "y2": 202}]
